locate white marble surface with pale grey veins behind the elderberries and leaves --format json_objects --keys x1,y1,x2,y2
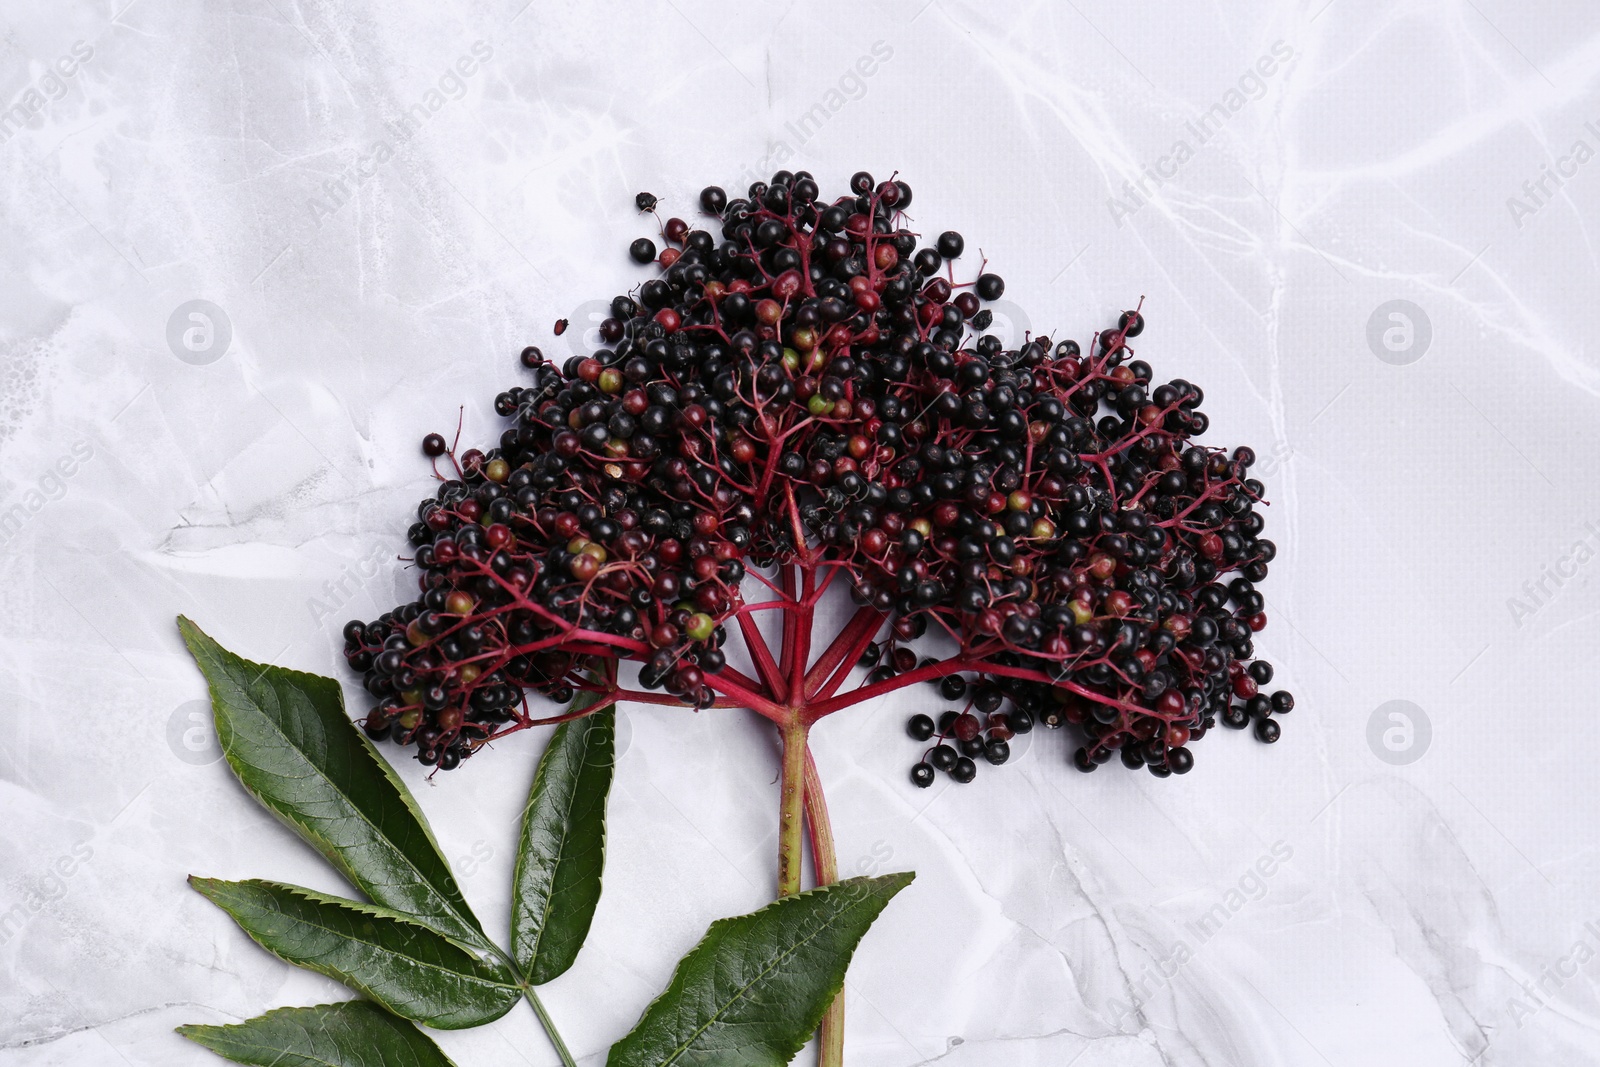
[{"x1": 0, "y1": 0, "x2": 1600, "y2": 1067}]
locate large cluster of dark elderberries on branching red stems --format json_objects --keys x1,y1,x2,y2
[{"x1": 344, "y1": 171, "x2": 1294, "y2": 891}]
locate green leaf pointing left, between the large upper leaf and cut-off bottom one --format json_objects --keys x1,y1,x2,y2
[{"x1": 189, "y1": 878, "x2": 522, "y2": 1030}]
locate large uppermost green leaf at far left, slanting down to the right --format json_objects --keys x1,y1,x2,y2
[{"x1": 178, "y1": 616, "x2": 491, "y2": 950}]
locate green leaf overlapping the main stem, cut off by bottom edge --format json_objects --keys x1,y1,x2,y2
[{"x1": 606, "y1": 872, "x2": 917, "y2": 1067}]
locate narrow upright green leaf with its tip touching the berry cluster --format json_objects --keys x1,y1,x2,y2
[{"x1": 510, "y1": 693, "x2": 616, "y2": 985}]
